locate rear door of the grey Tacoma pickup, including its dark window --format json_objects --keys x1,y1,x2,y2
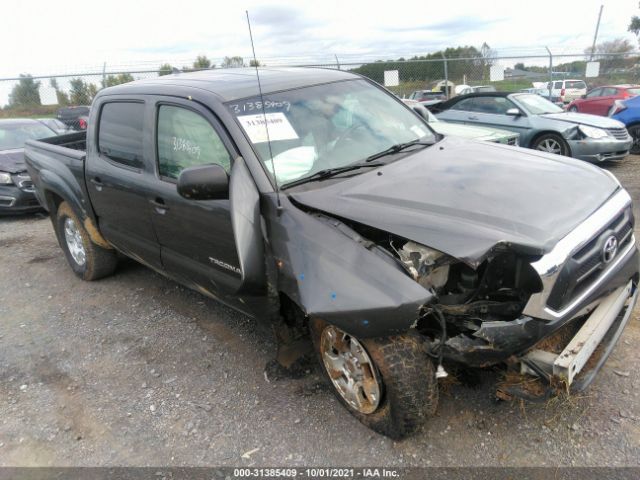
[{"x1": 86, "y1": 97, "x2": 161, "y2": 268}]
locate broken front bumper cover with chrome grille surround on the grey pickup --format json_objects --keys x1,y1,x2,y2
[{"x1": 444, "y1": 190, "x2": 640, "y2": 367}]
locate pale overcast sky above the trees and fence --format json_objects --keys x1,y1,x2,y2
[{"x1": 0, "y1": 0, "x2": 640, "y2": 77}]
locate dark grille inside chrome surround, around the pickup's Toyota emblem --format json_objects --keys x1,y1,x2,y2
[{"x1": 547, "y1": 208, "x2": 633, "y2": 310}]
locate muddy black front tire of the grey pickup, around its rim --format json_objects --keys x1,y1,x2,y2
[{"x1": 311, "y1": 320, "x2": 438, "y2": 440}]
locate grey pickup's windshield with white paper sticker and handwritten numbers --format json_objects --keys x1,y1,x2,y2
[{"x1": 227, "y1": 80, "x2": 435, "y2": 185}]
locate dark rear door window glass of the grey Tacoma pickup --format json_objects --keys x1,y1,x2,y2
[{"x1": 98, "y1": 102, "x2": 144, "y2": 168}]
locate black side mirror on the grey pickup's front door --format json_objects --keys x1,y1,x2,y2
[{"x1": 178, "y1": 164, "x2": 229, "y2": 200}]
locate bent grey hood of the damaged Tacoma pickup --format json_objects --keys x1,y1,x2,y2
[{"x1": 290, "y1": 137, "x2": 620, "y2": 267}]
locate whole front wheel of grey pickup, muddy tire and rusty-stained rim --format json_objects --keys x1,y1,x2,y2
[{"x1": 311, "y1": 320, "x2": 438, "y2": 439}]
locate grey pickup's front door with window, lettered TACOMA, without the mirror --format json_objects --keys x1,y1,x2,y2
[{"x1": 150, "y1": 99, "x2": 242, "y2": 296}]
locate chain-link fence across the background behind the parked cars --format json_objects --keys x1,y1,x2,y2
[{"x1": 0, "y1": 52, "x2": 640, "y2": 118}]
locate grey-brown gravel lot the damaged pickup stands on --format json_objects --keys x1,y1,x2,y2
[{"x1": 0, "y1": 157, "x2": 640, "y2": 466}]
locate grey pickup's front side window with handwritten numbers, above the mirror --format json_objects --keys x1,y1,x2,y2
[{"x1": 157, "y1": 105, "x2": 231, "y2": 179}]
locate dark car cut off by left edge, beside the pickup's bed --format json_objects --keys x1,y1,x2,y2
[{"x1": 0, "y1": 119, "x2": 56, "y2": 215}]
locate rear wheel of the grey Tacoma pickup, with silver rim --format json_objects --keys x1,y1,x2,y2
[{"x1": 52, "y1": 202, "x2": 118, "y2": 281}]
